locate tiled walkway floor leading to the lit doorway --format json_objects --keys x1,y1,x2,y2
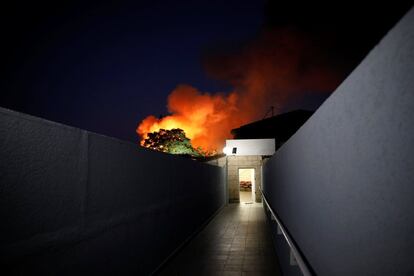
[{"x1": 158, "y1": 203, "x2": 281, "y2": 276}]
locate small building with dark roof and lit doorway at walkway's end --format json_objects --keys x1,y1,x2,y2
[{"x1": 208, "y1": 110, "x2": 313, "y2": 203}]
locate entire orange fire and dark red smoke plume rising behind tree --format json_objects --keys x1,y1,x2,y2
[{"x1": 136, "y1": 30, "x2": 341, "y2": 152}]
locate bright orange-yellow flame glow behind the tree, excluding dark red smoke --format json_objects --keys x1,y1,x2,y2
[{"x1": 137, "y1": 85, "x2": 243, "y2": 152}]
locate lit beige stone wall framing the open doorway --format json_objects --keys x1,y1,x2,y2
[{"x1": 227, "y1": 155, "x2": 262, "y2": 203}]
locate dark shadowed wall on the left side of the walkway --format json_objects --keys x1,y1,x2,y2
[{"x1": 0, "y1": 109, "x2": 225, "y2": 275}]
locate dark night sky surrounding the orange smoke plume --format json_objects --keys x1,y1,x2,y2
[{"x1": 0, "y1": 0, "x2": 412, "y2": 142}]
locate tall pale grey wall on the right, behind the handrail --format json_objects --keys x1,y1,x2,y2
[{"x1": 263, "y1": 10, "x2": 414, "y2": 275}]
